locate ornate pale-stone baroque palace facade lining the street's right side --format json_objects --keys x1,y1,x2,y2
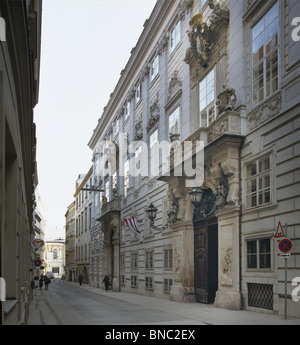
[{"x1": 66, "y1": 0, "x2": 300, "y2": 317}]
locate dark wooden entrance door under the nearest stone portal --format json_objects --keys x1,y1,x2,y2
[{"x1": 194, "y1": 218, "x2": 218, "y2": 304}]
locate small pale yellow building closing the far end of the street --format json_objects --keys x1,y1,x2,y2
[{"x1": 45, "y1": 238, "x2": 65, "y2": 277}]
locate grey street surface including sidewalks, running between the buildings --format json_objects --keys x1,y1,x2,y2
[{"x1": 28, "y1": 279, "x2": 300, "y2": 329}]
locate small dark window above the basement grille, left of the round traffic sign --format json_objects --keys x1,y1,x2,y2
[{"x1": 247, "y1": 238, "x2": 271, "y2": 269}]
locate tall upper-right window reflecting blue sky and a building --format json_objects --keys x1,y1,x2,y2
[{"x1": 252, "y1": 3, "x2": 279, "y2": 106}]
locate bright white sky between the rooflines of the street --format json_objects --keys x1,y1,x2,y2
[{"x1": 34, "y1": 0, "x2": 156, "y2": 237}]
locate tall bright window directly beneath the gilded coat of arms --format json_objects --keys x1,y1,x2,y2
[{"x1": 199, "y1": 69, "x2": 216, "y2": 127}]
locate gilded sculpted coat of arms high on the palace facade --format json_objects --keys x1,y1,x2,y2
[{"x1": 184, "y1": 12, "x2": 212, "y2": 68}]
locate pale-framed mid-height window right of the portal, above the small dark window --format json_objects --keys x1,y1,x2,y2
[{"x1": 246, "y1": 156, "x2": 271, "y2": 208}]
